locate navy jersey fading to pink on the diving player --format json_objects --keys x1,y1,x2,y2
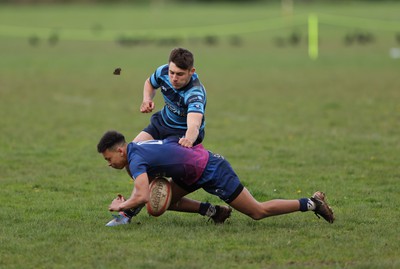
[{"x1": 127, "y1": 137, "x2": 209, "y2": 185}]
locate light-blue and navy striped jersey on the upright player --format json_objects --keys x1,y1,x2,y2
[{"x1": 150, "y1": 64, "x2": 207, "y2": 130}]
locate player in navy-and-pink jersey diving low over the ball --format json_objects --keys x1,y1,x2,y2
[{"x1": 97, "y1": 131, "x2": 334, "y2": 223}]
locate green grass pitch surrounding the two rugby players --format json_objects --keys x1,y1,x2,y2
[{"x1": 0, "y1": 3, "x2": 400, "y2": 268}]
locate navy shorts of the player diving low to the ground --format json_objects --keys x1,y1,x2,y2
[{"x1": 173, "y1": 152, "x2": 244, "y2": 204}]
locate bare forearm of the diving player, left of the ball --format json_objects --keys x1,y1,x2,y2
[{"x1": 108, "y1": 173, "x2": 150, "y2": 211}]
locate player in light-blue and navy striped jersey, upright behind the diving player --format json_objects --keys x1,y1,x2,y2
[{"x1": 133, "y1": 48, "x2": 207, "y2": 148}]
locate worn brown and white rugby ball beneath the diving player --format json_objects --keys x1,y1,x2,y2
[{"x1": 146, "y1": 177, "x2": 172, "y2": 217}]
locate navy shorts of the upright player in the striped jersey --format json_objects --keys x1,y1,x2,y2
[{"x1": 143, "y1": 111, "x2": 205, "y2": 146}]
